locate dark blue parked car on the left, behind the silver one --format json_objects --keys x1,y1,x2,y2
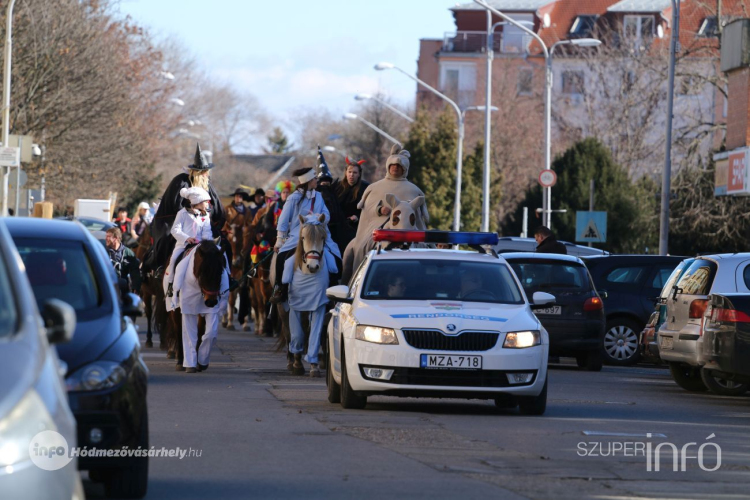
[{"x1": 5, "y1": 218, "x2": 149, "y2": 498}]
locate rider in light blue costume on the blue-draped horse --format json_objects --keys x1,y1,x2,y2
[{"x1": 271, "y1": 168, "x2": 341, "y2": 303}]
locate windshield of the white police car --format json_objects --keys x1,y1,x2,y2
[{"x1": 361, "y1": 259, "x2": 523, "y2": 304}]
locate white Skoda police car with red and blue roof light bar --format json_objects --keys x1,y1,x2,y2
[{"x1": 326, "y1": 230, "x2": 555, "y2": 415}]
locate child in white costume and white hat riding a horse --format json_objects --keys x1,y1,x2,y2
[{"x1": 164, "y1": 187, "x2": 212, "y2": 311}]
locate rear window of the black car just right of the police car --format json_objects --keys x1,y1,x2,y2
[{"x1": 509, "y1": 259, "x2": 590, "y2": 295}]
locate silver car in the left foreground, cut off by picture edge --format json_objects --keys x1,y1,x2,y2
[{"x1": 0, "y1": 220, "x2": 83, "y2": 499}]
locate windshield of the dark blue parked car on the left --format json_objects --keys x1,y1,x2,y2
[{"x1": 15, "y1": 238, "x2": 102, "y2": 318}]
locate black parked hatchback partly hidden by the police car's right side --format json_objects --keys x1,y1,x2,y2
[{"x1": 503, "y1": 253, "x2": 605, "y2": 371}]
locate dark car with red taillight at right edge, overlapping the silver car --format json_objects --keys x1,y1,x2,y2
[{"x1": 701, "y1": 292, "x2": 750, "y2": 394}]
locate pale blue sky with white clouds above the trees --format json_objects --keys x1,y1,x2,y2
[{"x1": 120, "y1": 0, "x2": 455, "y2": 150}]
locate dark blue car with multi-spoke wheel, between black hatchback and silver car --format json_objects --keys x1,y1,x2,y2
[{"x1": 583, "y1": 255, "x2": 683, "y2": 365}]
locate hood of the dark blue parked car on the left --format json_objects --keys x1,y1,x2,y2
[{"x1": 57, "y1": 314, "x2": 122, "y2": 373}]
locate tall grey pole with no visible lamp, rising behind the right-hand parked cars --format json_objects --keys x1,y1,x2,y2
[{"x1": 659, "y1": 0, "x2": 680, "y2": 255}]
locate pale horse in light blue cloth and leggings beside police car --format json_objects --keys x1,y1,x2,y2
[{"x1": 282, "y1": 214, "x2": 337, "y2": 377}]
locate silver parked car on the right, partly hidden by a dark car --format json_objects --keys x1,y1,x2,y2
[{"x1": 659, "y1": 253, "x2": 750, "y2": 395}]
